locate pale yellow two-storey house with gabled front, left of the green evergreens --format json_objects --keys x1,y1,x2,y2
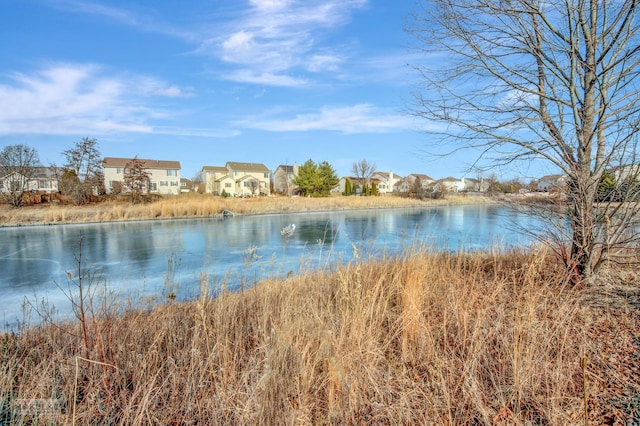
[{"x1": 202, "y1": 161, "x2": 271, "y2": 197}]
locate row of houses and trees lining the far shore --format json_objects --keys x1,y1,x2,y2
[{"x1": 0, "y1": 139, "x2": 638, "y2": 205}]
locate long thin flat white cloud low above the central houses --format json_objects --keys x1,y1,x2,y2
[{"x1": 236, "y1": 104, "x2": 413, "y2": 133}]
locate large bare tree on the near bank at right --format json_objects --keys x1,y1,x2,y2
[{"x1": 410, "y1": 0, "x2": 640, "y2": 281}]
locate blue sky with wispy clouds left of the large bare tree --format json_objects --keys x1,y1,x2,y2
[{"x1": 0, "y1": 0, "x2": 552, "y2": 179}]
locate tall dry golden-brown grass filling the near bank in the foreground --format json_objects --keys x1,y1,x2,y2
[{"x1": 0, "y1": 249, "x2": 640, "y2": 425}]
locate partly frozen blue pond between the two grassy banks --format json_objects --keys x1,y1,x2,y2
[{"x1": 0, "y1": 205, "x2": 540, "y2": 327}]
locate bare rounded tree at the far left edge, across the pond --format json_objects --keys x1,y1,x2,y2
[{"x1": 0, "y1": 145, "x2": 40, "y2": 207}]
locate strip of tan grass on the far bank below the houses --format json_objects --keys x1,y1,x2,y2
[{"x1": 0, "y1": 194, "x2": 490, "y2": 226}]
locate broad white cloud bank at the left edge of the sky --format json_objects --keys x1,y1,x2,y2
[{"x1": 0, "y1": 64, "x2": 220, "y2": 135}]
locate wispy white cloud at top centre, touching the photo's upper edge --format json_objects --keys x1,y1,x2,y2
[{"x1": 208, "y1": 0, "x2": 366, "y2": 86}]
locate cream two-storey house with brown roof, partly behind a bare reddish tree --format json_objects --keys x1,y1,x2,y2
[{"x1": 102, "y1": 157, "x2": 181, "y2": 195}]
